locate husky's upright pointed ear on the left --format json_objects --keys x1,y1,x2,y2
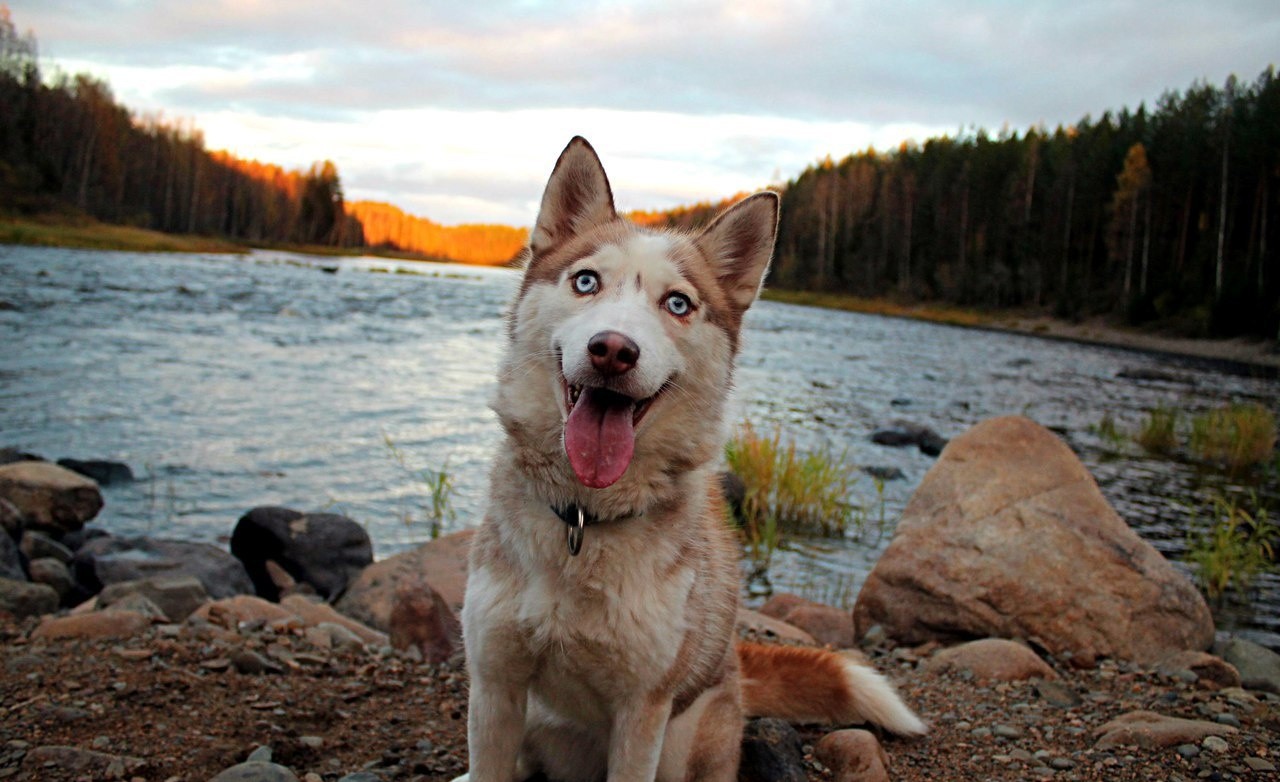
[{"x1": 529, "y1": 136, "x2": 618, "y2": 257}]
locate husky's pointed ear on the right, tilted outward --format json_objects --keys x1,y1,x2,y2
[{"x1": 695, "y1": 191, "x2": 778, "y2": 311}]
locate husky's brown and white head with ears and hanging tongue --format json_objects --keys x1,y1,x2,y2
[{"x1": 497, "y1": 138, "x2": 778, "y2": 489}]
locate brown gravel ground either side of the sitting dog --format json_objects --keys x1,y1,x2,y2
[{"x1": 0, "y1": 623, "x2": 1280, "y2": 782}]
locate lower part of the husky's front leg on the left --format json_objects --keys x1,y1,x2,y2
[{"x1": 467, "y1": 676, "x2": 529, "y2": 782}]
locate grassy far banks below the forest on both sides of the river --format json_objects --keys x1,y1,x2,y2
[{"x1": 0, "y1": 215, "x2": 1280, "y2": 376}]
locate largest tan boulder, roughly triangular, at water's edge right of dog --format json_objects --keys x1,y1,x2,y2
[{"x1": 854, "y1": 416, "x2": 1213, "y2": 666}]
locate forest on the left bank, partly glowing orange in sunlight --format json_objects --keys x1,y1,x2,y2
[{"x1": 0, "y1": 5, "x2": 527, "y2": 264}]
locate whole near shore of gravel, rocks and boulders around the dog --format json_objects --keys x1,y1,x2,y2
[{"x1": 0, "y1": 419, "x2": 1280, "y2": 782}]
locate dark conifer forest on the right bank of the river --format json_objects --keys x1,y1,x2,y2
[{"x1": 771, "y1": 67, "x2": 1280, "y2": 338}]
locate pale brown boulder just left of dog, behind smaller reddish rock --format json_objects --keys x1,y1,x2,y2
[{"x1": 334, "y1": 530, "x2": 474, "y2": 632}]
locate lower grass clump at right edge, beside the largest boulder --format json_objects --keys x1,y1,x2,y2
[{"x1": 1185, "y1": 494, "x2": 1280, "y2": 599}]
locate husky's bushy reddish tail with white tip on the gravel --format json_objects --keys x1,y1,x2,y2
[{"x1": 737, "y1": 644, "x2": 928, "y2": 736}]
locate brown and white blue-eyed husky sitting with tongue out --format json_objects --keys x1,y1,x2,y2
[{"x1": 462, "y1": 138, "x2": 925, "y2": 782}]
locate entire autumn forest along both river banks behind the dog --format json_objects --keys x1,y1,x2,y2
[{"x1": 0, "y1": 5, "x2": 1280, "y2": 337}]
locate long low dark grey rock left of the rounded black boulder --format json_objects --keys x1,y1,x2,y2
[{"x1": 72, "y1": 538, "x2": 253, "y2": 599}]
